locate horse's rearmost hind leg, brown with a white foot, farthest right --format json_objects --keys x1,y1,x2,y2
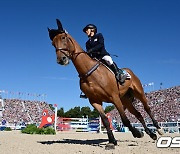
[{"x1": 133, "y1": 85, "x2": 163, "y2": 135}]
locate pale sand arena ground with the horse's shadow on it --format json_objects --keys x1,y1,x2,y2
[{"x1": 0, "y1": 131, "x2": 180, "y2": 154}]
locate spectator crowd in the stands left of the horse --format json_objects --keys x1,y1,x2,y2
[{"x1": 0, "y1": 99, "x2": 53, "y2": 125}]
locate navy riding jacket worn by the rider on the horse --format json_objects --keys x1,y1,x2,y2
[{"x1": 86, "y1": 33, "x2": 110, "y2": 59}]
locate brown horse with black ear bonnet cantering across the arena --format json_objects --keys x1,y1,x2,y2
[{"x1": 48, "y1": 19, "x2": 163, "y2": 146}]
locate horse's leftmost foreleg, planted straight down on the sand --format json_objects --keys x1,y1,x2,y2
[{"x1": 90, "y1": 100, "x2": 117, "y2": 145}]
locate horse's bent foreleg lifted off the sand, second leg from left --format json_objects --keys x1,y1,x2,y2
[{"x1": 114, "y1": 96, "x2": 144, "y2": 138}]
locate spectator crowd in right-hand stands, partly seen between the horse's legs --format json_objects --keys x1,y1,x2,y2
[{"x1": 110, "y1": 86, "x2": 180, "y2": 123}]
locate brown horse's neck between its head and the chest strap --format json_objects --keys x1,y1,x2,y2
[{"x1": 69, "y1": 36, "x2": 96, "y2": 74}]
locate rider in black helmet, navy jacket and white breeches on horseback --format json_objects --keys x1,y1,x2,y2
[{"x1": 83, "y1": 24, "x2": 127, "y2": 84}]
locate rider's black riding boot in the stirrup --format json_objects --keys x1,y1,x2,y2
[{"x1": 110, "y1": 63, "x2": 127, "y2": 83}]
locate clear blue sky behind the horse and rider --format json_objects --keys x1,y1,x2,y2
[{"x1": 0, "y1": 0, "x2": 180, "y2": 110}]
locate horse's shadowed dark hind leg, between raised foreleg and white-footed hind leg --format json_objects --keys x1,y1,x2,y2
[{"x1": 121, "y1": 97, "x2": 157, "y2": 140}]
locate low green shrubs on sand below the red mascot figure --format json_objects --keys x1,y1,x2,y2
[{"x1": 21, "y1": 124, "x2": 56, "y2": 135}]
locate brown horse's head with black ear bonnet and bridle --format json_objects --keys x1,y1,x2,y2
[{"x1": 48, "y1": 19, "x2": 75, "y2": 65}]
